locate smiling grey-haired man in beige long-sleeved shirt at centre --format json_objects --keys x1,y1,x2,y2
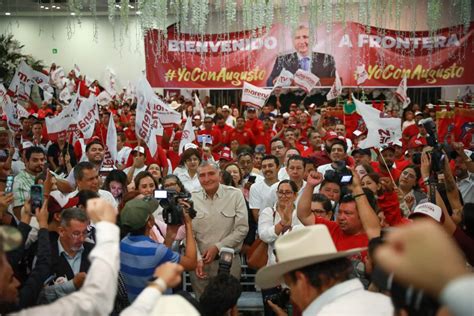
[{"x1": 190, "y1": 162, "x2": 249, "y2": 298}]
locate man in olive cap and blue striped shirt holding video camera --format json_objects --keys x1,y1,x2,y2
[{"x1": 120, "y1": 199, "x2": 197, "y2": 302}]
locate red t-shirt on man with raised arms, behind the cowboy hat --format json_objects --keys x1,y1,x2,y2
[{"x1": 314, "y1": 216, "x2": 369, "y2": 261}]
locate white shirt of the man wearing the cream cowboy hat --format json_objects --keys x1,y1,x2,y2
[{"x1": 303, "y1": 279, "x2": 393, "y2": 316}]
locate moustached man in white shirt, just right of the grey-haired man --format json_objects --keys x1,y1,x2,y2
[{"x1": 249, "y1": 155, "x2": 279, "y2": 222}]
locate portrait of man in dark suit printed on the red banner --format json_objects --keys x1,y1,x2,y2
[{"x1": 267, "y1": 24, "x2": 336, "y2": 87}]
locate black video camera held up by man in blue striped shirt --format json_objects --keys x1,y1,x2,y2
[{"x1": 154, "y1": 190, "x2": 196, "y2": 225}]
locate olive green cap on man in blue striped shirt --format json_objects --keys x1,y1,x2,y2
[{"x1": 120, "y1": 199, "x2": 159, "y2": 230}]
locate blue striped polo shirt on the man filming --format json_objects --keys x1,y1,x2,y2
[{"x1": 120, "y1": 235, "x2": 181, "y2": 302}]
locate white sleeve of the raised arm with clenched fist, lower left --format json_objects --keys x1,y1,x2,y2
[{"x1": 13, "y1": 222, "x2": 120, "y2": 316}]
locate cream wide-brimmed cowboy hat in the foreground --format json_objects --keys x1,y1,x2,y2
[{"x1": 255, "y1": 225, "x2": 367, "y2": 289}]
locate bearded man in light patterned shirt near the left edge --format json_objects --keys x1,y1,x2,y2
[{"x1": 13, "y1": 146, "x2": 46, "y2": 219}]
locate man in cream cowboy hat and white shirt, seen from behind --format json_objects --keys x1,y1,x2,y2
[{"x1": 255, "y1": 225, "x2": 394, "y2": 316}]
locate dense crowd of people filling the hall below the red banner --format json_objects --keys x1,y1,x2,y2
[{"x1": 0, "y1": 63, "x2": 474, "y2": 315}]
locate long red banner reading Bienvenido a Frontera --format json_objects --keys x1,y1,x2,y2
[{"x1": 145, "y1": 22, "x2": 474, "y2": 89}]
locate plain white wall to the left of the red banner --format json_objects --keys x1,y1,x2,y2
[{"x1": 0, "y1": 16, "x2": 145, "y2": 86}]
